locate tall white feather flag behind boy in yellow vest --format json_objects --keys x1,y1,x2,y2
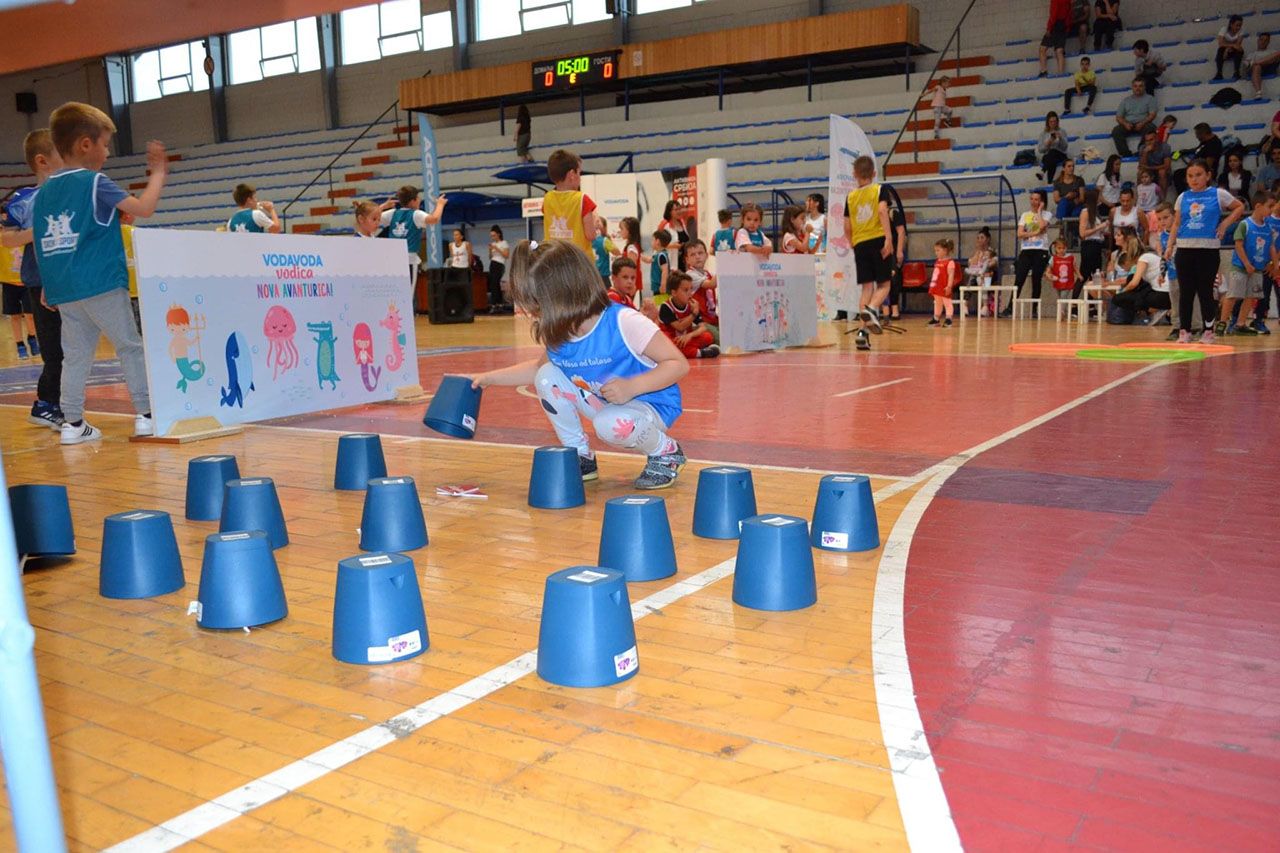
[{"x1": 818, "y1": 115, "x2": 879, "y2": 312}]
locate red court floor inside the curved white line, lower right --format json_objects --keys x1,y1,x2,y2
[{"x1": 905, "y1": 353, "x2": 1280, "y2": 850}]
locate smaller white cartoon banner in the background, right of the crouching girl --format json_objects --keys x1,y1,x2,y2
[{"x1": 716, "y1": 252, "x2": 818, "y2": 352}]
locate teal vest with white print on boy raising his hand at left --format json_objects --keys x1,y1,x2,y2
[{"x1": 32, "y1": 169, "x2": 129, "y2": 305}]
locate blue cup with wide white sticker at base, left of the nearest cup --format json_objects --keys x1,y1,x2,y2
[{"x1": 333, "y1": 553, "x2": 430, "y2": 663}]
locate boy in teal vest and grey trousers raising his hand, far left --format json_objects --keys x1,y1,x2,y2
[{"x1": 32, "y1": 101, "x2": 169, "y2": 444}]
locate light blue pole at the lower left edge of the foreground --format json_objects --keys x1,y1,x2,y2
[{"x1": 0, "y1": 470, "x2": 67, "y2": 853}]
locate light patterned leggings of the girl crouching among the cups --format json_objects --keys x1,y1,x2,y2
[{"x1": 534, "y1": 364, "x2": 676, "y2": 456}]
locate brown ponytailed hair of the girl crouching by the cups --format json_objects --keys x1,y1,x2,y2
[{"x1": 511, "y1": 240, "x2": 609, "y2": 350}]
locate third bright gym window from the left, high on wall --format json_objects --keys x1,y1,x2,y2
[{"x1": 338, "y1": 0, "x2": 453, "y2": 65}]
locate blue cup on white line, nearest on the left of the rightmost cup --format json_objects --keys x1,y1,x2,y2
[{"x1": 733, "y1": 515, "x2": 818, "y2": 610}]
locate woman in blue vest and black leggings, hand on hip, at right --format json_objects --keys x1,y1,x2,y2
[{"x1": 1165, "y1": 160, "x2": 1244, "y2": 343}]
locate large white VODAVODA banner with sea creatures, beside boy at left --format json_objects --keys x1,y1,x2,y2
[{"x1": 134, "y1": 228, "x2": 419, "y2": 435}]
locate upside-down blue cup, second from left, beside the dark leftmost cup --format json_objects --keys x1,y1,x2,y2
[{"x1": 97, "y1": 510, "x2": 187, "y2": 598}]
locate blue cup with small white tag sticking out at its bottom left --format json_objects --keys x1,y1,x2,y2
[{"x1": 196, "y1": 530, "x2": 289, "y2": 629}]
